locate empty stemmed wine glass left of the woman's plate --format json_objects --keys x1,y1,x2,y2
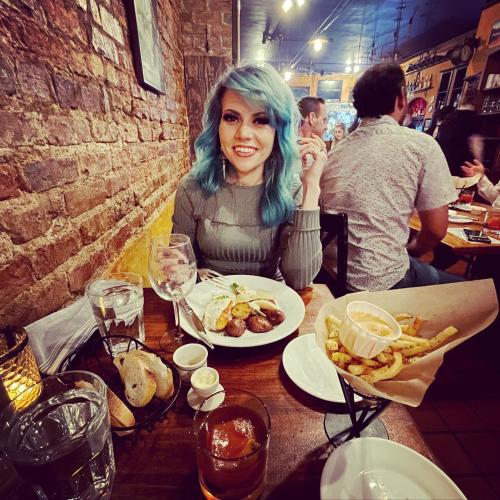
[{"x1": 148, "y1": 234, "x2": 196, "y2": 352}]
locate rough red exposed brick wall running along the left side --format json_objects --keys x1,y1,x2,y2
[{"x1": 0, "y1": 0, "x2": 190, "y2": 326}]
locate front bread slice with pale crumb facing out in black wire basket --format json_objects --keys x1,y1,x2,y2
[{"x1": 113, "y1": 352, "x2": 157, "y2": 408}]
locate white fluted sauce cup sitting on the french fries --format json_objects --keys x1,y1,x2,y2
[{"x1": 339, "y1": 300, "x2": 401, "y2": 358}]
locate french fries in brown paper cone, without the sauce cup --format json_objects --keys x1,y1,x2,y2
[{"x1": 315, "y1": 280, "x2": 498, "y2": 406}]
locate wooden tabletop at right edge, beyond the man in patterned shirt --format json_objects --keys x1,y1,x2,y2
[{"x1": 409, "y1": 203, "x2": 500, "y2": 256}]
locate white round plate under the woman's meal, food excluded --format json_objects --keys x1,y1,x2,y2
[{"x1": 180, "y1": 274, "x2": 305, "y2": 347}]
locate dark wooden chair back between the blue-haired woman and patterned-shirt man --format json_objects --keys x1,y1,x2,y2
[{"x1": 314, "y1": 213, "x2": 347, "y2": 297}]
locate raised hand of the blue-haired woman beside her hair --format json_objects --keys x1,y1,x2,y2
[{"x1": 299, "y1": 135, "x2": 327, "y2": 210}]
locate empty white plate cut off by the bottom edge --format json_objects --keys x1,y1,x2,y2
[{"x1": 320, "y1": 437, "x2": 466, "y2": 500}]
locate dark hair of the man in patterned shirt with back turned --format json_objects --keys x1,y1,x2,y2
[{"x1": 352, "y1": 63, "x2": 405, "y2": 118}]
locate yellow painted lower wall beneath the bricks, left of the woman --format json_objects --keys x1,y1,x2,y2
[{"x1": 109, "y1": 196, "x2": 174, "y2": 287}]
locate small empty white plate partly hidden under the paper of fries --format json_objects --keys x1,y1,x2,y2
[{"x1": 282, "y1": 334, "x2": 361, "y2": 403}]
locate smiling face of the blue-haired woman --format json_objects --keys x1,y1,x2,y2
[{"x1": 219, "y1": 89, "x2": 276, "y2": 185}]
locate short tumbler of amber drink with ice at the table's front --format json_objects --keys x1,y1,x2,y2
[{"x1": 194, "y1": 389, "x2": 271, "y2": 500}]
